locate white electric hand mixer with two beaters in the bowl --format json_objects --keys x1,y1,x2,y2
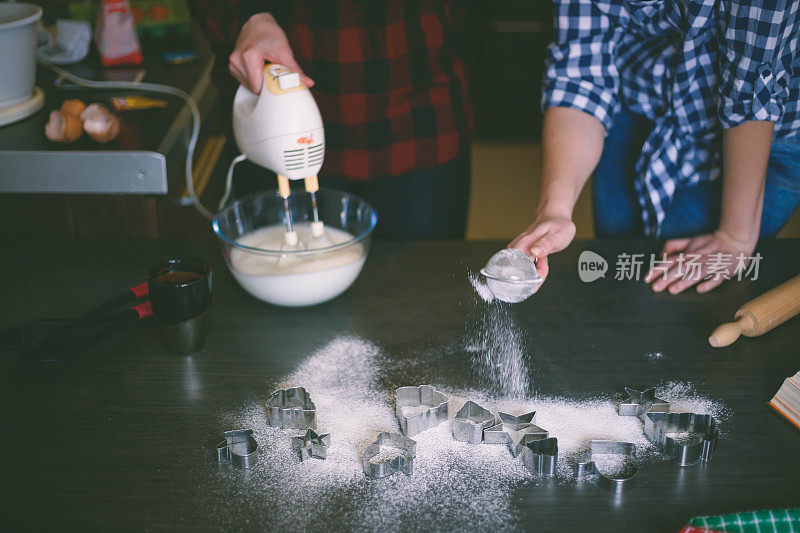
[{"x1": 233, "y1": 63, "x2": 334, "y2": 251}]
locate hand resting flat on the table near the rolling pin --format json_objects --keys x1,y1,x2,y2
[{"x1": 644, "y1": 229, "x2": 758, "y2": 294}]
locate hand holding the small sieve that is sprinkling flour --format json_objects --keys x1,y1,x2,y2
[{"x1": 508, "y1": 213, "x2": 575, "y2": 290}]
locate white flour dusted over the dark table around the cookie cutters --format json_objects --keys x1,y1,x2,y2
[{"x1": 213, "y1": 337, "x2": 732, "y2": 530}]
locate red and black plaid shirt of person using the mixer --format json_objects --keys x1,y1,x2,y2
[{"x1": 194, "y1": 0, "x2": 472, "y2": 180}]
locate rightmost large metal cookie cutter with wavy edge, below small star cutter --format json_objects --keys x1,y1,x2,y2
[{"x1": 644, "y1": 413, "x2": 719, "y2": 466}]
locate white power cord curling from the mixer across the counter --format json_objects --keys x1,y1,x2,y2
[{"x1": 39, "y1": 59, "x2": 216, "y2": 219}]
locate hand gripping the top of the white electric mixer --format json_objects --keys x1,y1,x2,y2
[{"x1": 228, "y1": 13, "x2": 314, "y2": 94}]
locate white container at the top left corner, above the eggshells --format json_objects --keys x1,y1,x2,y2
[{"x1": 0, "y1": 2, "x2": 42, "y2": 108}]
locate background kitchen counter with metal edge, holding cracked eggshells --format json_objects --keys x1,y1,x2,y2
[{"x1": 0, "y1": 27, "x2": 214, "y2": 200}]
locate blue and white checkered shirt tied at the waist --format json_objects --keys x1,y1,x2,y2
[{"x1": 542, "y1": 0, "x2": 800, "y2": 235}]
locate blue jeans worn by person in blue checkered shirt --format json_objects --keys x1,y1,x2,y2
[{"x1": 593, "y1": 110, "x2": 800, "y2": 239}]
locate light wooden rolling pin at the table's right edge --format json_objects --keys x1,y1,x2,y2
[{"x1": 708, "y1": 276, "x2": 800, "y2": 348}]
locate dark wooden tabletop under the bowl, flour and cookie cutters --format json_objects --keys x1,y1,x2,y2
[{"x1": 0, "y1": 240, "x2": 800, "y2": 531}]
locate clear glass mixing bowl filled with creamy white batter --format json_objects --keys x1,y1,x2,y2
[{"x1": 212, "y1": 189, "x2": 378, "y2": 307}]
